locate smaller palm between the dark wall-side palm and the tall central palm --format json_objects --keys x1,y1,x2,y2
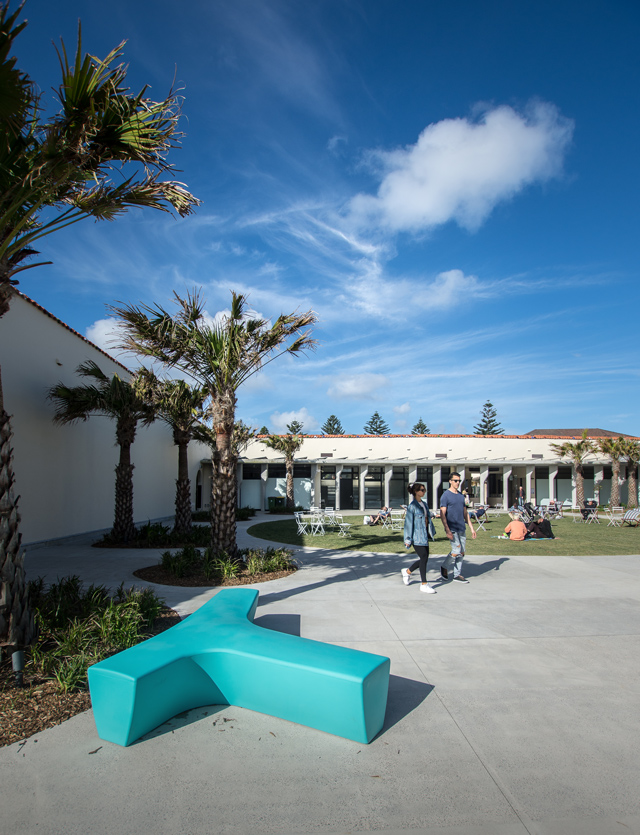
[{"x1": 133, "y1": 368, "x2": 207, "y2": 534}]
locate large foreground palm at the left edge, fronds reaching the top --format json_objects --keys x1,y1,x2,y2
[{"x1": 0, "y1": 3, "x2": 199, "y2": 646}]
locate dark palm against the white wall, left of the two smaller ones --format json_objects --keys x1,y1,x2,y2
[{"x1": 49, "y1": 360, "x2": 155, "y2": 543}]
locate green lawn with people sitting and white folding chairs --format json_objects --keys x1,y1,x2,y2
[{"x1": 249, "y1": 515, "x2": 640, "y2": 556}]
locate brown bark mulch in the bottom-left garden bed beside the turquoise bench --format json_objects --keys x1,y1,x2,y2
[{"x1": 0, "y1": 607, "x2": 180, "y2": 747}]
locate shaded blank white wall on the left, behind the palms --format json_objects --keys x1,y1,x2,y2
[{"x1": 0, "y1": 296, "x2": 202, "y2": 544}]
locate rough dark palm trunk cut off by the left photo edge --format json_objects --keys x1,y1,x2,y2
[{"x1": 0, "y1": 396, "x2": 36, "y2": 647}]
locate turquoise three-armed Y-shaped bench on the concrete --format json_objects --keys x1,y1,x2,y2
[{"x1": 88, "y1": 589, "x2": 389, "y2": 745}]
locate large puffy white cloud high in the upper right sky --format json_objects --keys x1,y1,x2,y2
[{"x1": 350, "y1": 102, "x2": 573, "y2": 237}]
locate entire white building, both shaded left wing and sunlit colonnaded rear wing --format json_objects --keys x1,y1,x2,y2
[{"x1": 0, "y1": 294, "x2": 627, "y2": 544}]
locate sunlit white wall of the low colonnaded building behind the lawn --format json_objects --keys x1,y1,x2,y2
[{"x1": 239, "y1": 435, "x2": 640, "y2": 511}]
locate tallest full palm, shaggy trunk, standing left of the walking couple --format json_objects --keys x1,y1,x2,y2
[{"x1": 111, "y1": 293, "x2": 317, "y2": 556}]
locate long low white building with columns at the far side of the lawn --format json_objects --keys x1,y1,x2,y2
[{"x1": 229, "y1": 429, "x2": 627, "y2": 511}]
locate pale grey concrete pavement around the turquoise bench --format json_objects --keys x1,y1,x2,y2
[{"x1": 0, "y1": 522, "x2": 640, "y2": 835}]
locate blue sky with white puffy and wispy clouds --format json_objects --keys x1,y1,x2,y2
[{"x1": 15, "y1": 0, "x2": 640, "y2": 435}]
